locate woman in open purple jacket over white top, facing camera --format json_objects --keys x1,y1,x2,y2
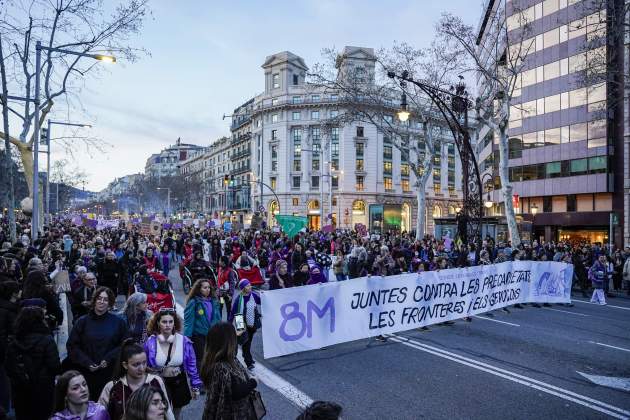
[{"x1": 144, "y1": 308, "x2": 202, "y2": 419}]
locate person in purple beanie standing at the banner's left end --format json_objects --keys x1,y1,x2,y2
[{"x1": 228, "y1": 279, "x2": 261, "y2": 370}]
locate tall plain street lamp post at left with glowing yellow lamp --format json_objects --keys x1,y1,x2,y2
[{"x1": 31, "y1": 41, "x2": 116, "y2": 243}]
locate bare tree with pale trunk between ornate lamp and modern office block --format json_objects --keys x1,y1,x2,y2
[{"x1": 436, "y1": 6, "x2": 535, "y2": 246}]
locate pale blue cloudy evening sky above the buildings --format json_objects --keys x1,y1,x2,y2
[{"x1": 44, "y1": 0, "x2": 481, "y2": 191}]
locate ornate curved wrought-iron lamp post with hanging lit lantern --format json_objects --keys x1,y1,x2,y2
[{"x1": 387, "y1": 71, "x2": 483, "y2": 253}]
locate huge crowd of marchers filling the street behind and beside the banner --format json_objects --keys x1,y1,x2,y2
[{"x1": 0, "y1": 213, "x2": 630, "y2": 420}]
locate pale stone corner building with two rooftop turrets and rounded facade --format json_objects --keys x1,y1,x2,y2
[{"x1": 244, "y1": 47, "x2": 462, "y2": 233}]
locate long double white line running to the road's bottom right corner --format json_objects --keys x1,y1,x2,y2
[{"x1": 387, "y1": 334, "x2": 630, "y2": 419}]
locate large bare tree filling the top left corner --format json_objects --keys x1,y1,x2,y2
[{"x1": 0, "y1": 0, "x2": 149, "y2": 199}]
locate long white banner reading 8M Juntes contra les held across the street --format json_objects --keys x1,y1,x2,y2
[{"x1": 262, "y1": 261, "x2": 573, "y2": 358}]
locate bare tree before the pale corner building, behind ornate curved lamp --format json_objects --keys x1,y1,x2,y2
[{"x1": 310, "y1": 43, "x2": 458, "y2": 239}]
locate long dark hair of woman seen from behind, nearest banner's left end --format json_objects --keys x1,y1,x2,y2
[{"x1": 201, "y1": 322, "x2": 238, "y2": 386}]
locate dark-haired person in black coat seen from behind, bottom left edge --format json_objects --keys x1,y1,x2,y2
[{"x1": 6, "y1": 306, "x2": 61, "y2": 420}]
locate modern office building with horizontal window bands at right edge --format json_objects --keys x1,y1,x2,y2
[{"x1": 478, "y1": 0, "x2": 629, "y2": 246}]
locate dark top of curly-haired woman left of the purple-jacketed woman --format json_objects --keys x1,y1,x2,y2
[{"x1": 67, "y1": 311, "x2": 128, "y2": 369}]
